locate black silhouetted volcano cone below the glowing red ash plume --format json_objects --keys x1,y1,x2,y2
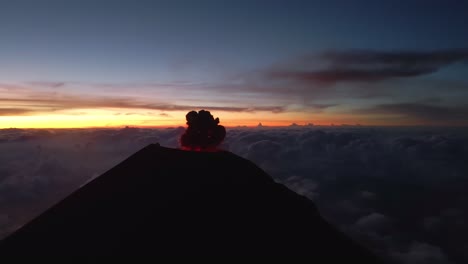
[{"x1": 0, "y1": 145, "x2": 379, "y2": 258}]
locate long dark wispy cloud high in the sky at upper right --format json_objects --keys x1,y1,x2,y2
[{"x1": 266, "y1": 50, "x2": 468, "y2": 84}]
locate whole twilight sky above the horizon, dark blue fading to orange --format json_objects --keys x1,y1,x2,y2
[{"x1": 0, "y1": 0, "x2": 468, "y2": 128}]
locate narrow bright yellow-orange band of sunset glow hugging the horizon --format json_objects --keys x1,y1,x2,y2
[{"x1": 0, "y1": 108, "x2": 460, "y2": 129}]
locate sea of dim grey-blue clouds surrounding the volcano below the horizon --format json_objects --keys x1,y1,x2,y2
[{"x1": 0, "y1": 126, "x2": 468, "y2": 264}]
